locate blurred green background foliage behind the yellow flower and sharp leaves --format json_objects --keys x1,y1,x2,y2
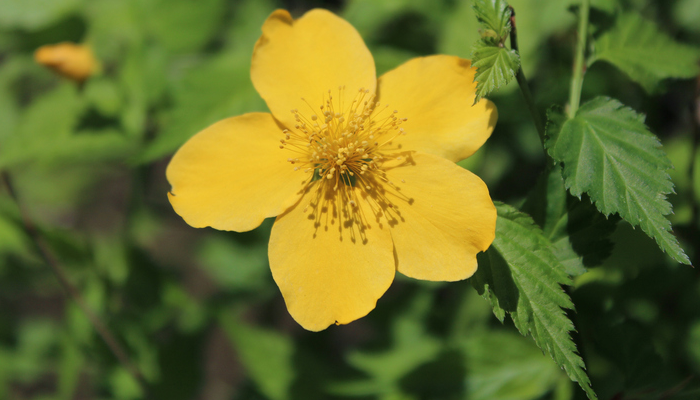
[{"x1": 0, "y1": 0, "x2": 700, "y2": 400}]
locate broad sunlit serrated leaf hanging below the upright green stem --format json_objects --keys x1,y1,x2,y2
[{"x1": 545, "y1": 97, "x2": 690, "y2": 264}]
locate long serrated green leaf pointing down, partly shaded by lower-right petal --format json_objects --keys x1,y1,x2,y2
[{"x1": 472, "y1": 203, "x2": 596, "y2": 399}]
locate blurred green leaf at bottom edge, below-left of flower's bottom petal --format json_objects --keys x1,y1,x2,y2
[{"x1": 219, "y1": 313, "x2": 296, "y2": 400}]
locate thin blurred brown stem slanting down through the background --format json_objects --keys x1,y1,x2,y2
[{"x1": 0, "y1": 171, "x2": 148, "y2": 396}]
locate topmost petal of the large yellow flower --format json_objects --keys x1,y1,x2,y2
[{"x1": 250, "y1": 9, "x2": 377, "y2": 128}]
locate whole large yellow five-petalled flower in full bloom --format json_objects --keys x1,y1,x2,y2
[{"x1": 166, "y1": 10, "x2": 497, "y2": 331}]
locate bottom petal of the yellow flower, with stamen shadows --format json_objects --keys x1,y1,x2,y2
[{"x1": 269, "y1": 181, "x2": 396, "y2": 331}]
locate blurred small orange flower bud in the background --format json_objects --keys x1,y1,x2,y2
[{"x1": 34, "y1": 42, "x2": 97, "y2": 82}]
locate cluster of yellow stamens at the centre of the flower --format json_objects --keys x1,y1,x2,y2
[{"x1": 280, "y1": 87, "x2": 407, "y2": 238}]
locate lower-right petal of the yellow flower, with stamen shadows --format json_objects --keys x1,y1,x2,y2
[{"x1": 386, "y1": 153, "x2": 496, "y2": 281}]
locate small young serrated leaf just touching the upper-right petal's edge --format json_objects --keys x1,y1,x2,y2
[{"x1": 472, "y1": 39, "x2": 520, "y2": 104}]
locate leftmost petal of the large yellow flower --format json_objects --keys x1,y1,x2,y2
[{"x1": 166, "y1": 113, "x2": 304, "y2": 232}]
